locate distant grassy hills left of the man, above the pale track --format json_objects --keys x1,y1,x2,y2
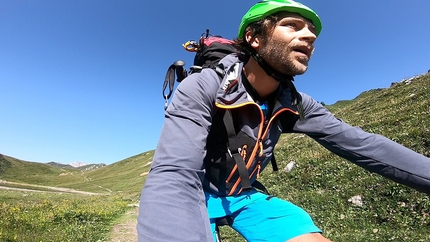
[{"x1": 0, "y1": 151, "x2": 154, "y2": 199}]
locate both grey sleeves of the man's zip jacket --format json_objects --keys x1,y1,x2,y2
[{"x1": 137, "y1": 57, "x2": 430, "y2": 242}]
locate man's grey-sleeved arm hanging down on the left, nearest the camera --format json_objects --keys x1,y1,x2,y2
[{"x1": 137, "y1": 71, "x2": 219, "y2": 242}]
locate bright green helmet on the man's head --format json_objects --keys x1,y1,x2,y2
[{"x1": 237, "y1": 0, "x2": 322, "y2": 39}]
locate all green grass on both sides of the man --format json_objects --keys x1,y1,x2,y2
[{"x1": 0, "y1": 74, "x2": 430, "y2": 242}]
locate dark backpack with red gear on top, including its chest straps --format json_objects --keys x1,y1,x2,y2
[{"x1": 163, "y1": 30, "x2": 278, "y2": 193}]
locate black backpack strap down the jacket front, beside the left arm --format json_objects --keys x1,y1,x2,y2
[{"x1": 223, "y1": 109, "x2": 252, "y2": 190}]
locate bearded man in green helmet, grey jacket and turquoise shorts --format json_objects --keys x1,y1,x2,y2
[{"x1": 138, "y1": 0, "x2": 430, "y2": 242}]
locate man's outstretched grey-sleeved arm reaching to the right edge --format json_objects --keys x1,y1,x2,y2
[{"x1": 294, "y1": 94, "x2": 430, "y2": 194}]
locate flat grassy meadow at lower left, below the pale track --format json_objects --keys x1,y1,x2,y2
[{"x1": 0, "y1": 190, "x2": 127, "y2": 242}]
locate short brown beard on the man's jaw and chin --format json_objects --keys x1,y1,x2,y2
[{"x1": 258, "y1": 38, "x2": 309, "y2": 76}]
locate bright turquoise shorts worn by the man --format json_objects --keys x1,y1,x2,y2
[{"x1": 206, "y1": 191, "x2": 321, "y2": 242}]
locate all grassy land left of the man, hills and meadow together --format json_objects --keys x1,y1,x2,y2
[{"x1": 0, "y1": 151, "x2": 153, "y2": 242}]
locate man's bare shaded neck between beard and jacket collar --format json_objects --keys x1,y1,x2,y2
[{"x1": 243, "y1": 57, "x2": 279, "y2": 98}]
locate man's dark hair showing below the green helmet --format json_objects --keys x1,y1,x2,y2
[{"x1": 233, "y1": 12, "x2": 280, "y2": 51}]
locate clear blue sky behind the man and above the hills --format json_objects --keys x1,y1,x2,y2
[{"x1": 0, "y1": 0, "x2": 430, "y2": 164}]
